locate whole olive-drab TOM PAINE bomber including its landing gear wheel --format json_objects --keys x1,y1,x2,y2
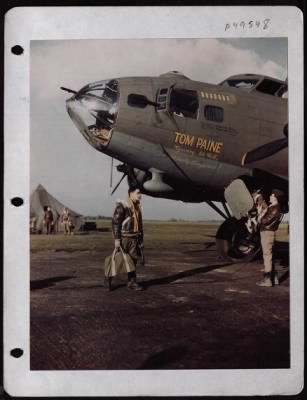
[{"x1": 63, "y1": 71, "x2": 288, "y2": 261}]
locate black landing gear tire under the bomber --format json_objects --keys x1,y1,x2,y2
[{"x1": 216, "y1": 218, "x2": 261, "y2": 263}]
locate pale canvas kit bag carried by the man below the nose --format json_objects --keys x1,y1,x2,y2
[{"x1": 104, "y1": 247, "x2": 135, "y2": 278}]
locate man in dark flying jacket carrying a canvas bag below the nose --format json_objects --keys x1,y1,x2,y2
[{"x1": 105, "y1": 186, "x2": 143, "y2": 290}]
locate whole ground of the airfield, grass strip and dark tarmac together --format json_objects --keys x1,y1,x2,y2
[{"x1": 30, "y1": 220, "x2": 290, "y2": 370}]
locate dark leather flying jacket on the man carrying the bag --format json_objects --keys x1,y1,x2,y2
[{"x1": 112, "y1": 200, "x2": 143, "y2": 241}]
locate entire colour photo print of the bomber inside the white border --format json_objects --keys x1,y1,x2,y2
[{"x1": 29, "y1": 37, "x2": 291, "y2": 371}]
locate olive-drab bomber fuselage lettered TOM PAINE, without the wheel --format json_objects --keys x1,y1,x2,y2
[{"x1": 67, "y1": 74, "x2": 288, "y2": 201}]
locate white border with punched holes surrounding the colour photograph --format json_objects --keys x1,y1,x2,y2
[{"x1": 4, "y1": 6, "x2": 304, "y2": 396}]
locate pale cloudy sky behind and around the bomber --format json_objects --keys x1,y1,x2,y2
[{"x1": 30, "y1": 38, "x2": 287, "y2": 220}]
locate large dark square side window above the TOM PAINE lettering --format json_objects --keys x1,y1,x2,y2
[{"x1": 169, "y1": 88, "x2": 198, "y2": 119}]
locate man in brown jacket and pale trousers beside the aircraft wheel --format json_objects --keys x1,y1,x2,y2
[{"x1": 257, "y1": 189, "x2": 284, "y2": 287}]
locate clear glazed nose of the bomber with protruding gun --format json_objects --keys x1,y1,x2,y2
[{"x1": 61, "y1": 79, "x2": 119, "y2": 151}]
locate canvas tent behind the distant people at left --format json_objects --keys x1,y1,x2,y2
[{"x1": 30, "y1": 185, "x2": 84, "y2": 233}]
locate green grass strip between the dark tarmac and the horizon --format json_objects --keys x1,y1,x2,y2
[{"x1": 30, "y1": 219, "x2": 288, "y2": 252}]
